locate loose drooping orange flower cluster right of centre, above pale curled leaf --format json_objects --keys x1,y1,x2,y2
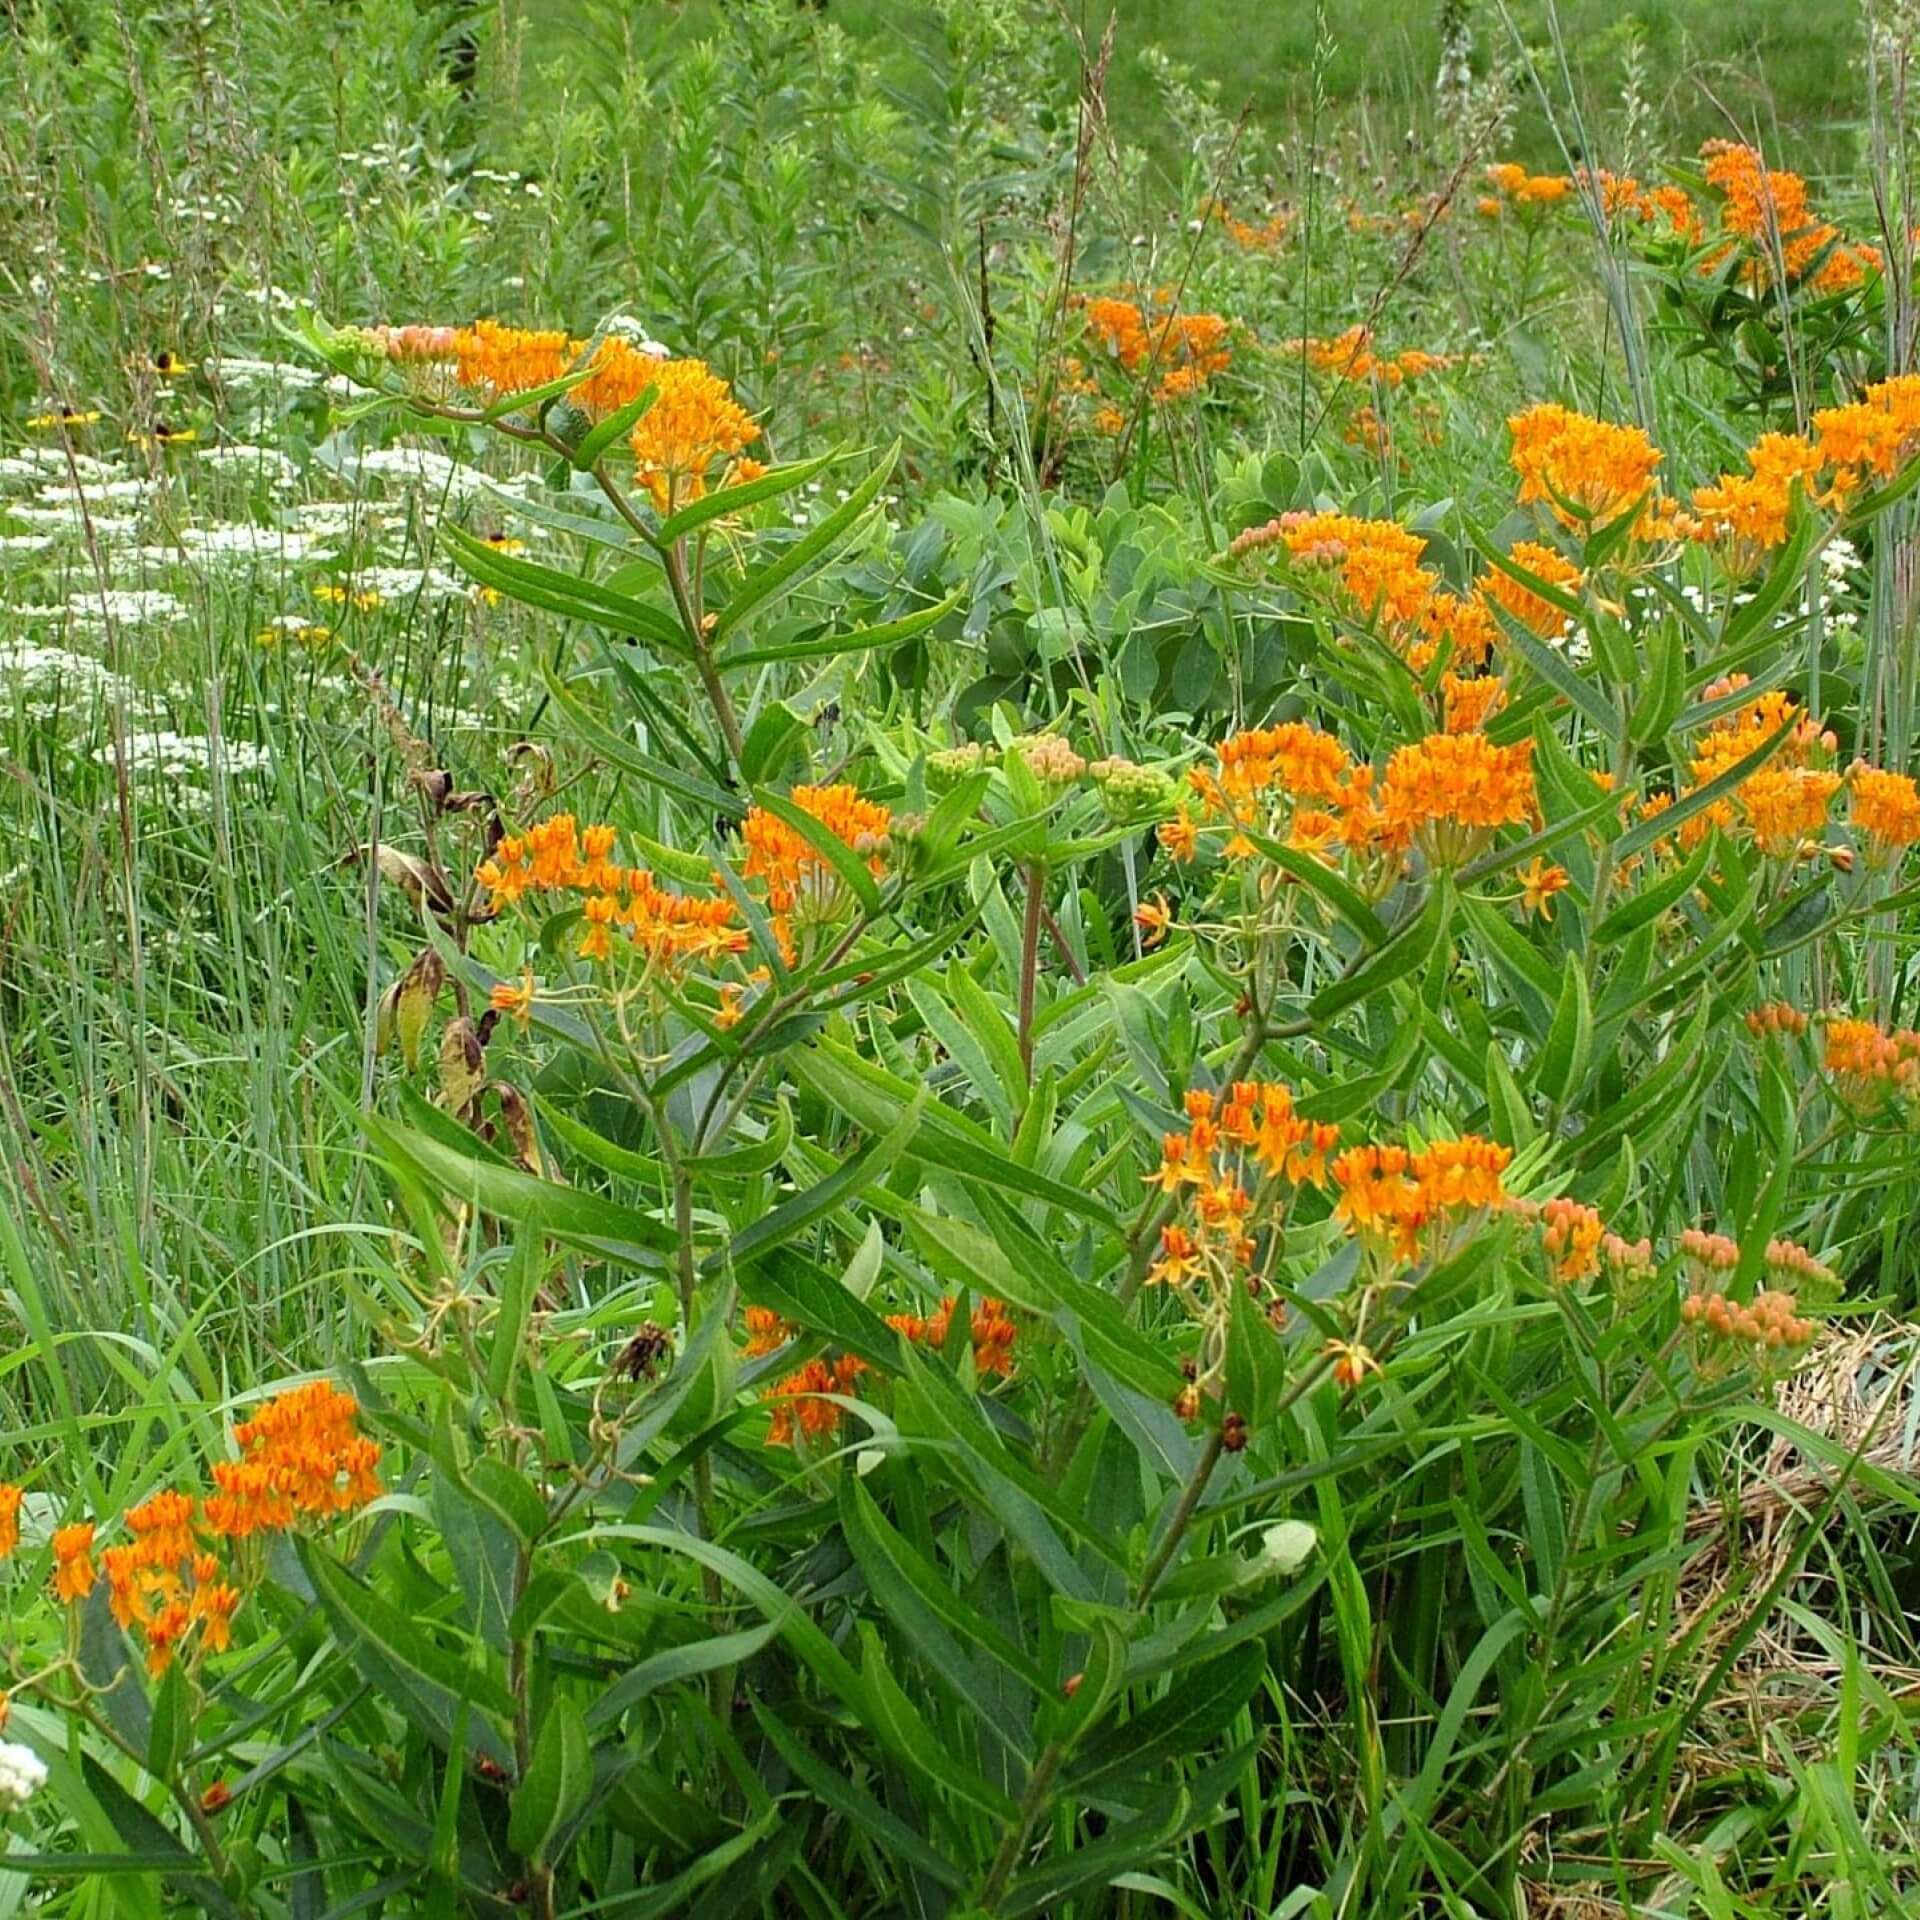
[{"x1": 1146, "y1": 1081, "x2": 1340, "y2": 1286}]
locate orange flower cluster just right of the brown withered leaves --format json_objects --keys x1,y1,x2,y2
[{"x1": 474, "y1": 814, "x2": 747, "y2": 973}]
